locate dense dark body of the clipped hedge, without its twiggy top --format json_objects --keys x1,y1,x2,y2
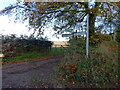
[{"x1": 2, "y1": 39, "x2": 53, "y2": 57}]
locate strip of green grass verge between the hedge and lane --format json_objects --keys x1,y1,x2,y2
[{"x1": 3, "y1": 47, "x2": 64, "y2": 62}]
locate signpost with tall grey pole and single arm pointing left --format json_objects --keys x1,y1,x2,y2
[{"x1": 62, "y1": 14, "x2": 89, "y2": 57}]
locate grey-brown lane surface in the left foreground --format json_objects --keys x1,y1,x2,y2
[{"x1": 2, "y1": 57, "x2": 62, "y2": 88}]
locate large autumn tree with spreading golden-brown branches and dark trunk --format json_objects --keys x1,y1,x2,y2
[{"x1": 0, "y1": 2, "x2": 118, "y2": 41}]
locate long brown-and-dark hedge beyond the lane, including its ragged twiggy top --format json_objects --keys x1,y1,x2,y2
[{"x1": 2, "y1": 34, "x2": 53, "y2": 57}]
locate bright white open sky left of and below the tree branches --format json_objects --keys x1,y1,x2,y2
[{"x1": 0, "y1": 0, "x2": 66, "y2": 41}]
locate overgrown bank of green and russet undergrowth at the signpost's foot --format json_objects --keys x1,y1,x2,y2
[{"x1": 57, "y1": 41, "x2": 120, "y2": 88}]
